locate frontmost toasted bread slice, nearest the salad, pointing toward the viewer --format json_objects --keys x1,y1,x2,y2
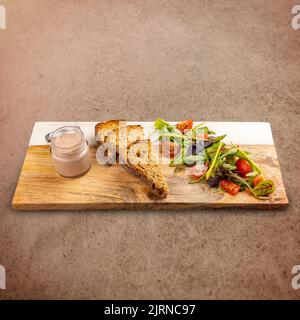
[{"x1": 123, "y1": 139, "x2": 169, "y2": 198}]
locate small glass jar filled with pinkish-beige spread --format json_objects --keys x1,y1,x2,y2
[{"x1": 46, "y1": 126, "x2": 92, "y2": 177}]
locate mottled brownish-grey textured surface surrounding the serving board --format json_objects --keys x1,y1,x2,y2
[{"x1": 0, "y1": 0, "x2": 300, "y2": 299}]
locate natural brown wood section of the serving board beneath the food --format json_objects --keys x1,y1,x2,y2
[{"x1": 12, "y1": 123, "x2": 288, "y2": 210}]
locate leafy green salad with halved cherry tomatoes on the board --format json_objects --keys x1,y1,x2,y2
[{"x1": 154, "y1": 118, "x2": 275, "y2": 199}]
